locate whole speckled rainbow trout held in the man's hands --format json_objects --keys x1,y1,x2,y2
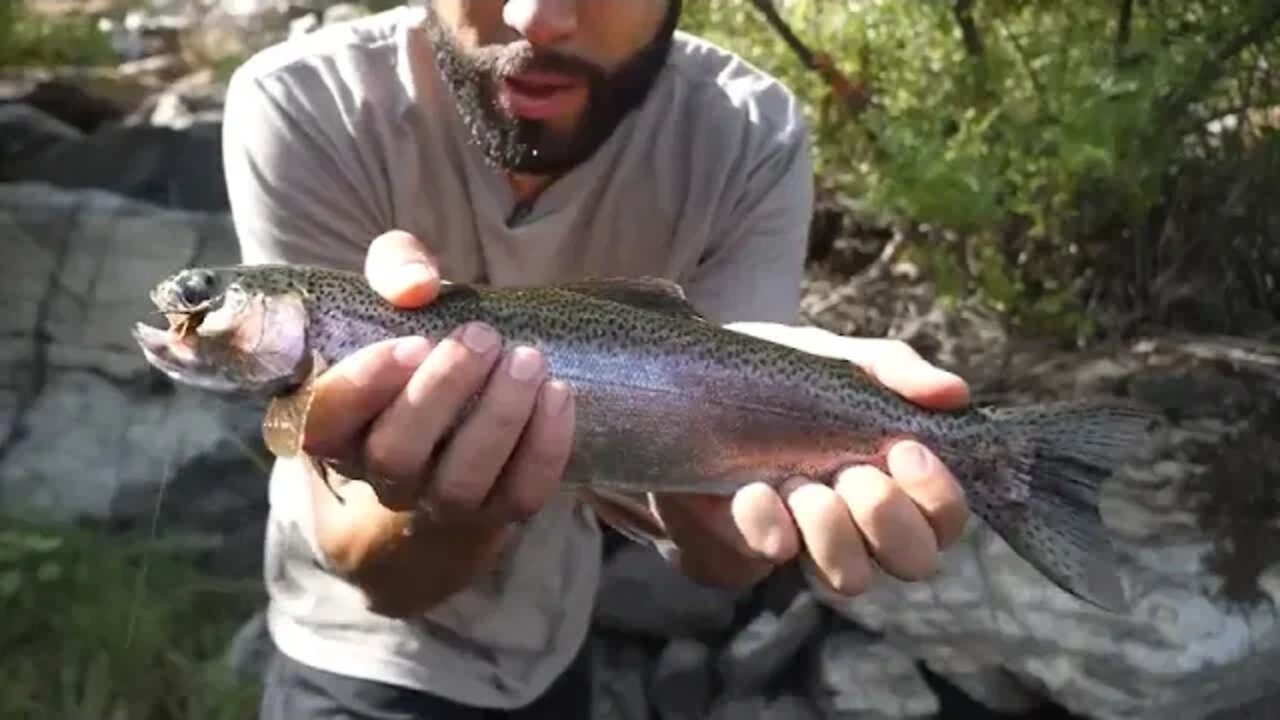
[{"x1": 133, "y1": 265, "x2": 1155, "y2": 611}]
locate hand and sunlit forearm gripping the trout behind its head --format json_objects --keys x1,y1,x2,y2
[{"x1": 294, "y1": 232, "x2": 573, "y2": 612}]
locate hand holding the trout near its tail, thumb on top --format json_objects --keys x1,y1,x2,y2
[{"x1": 653, "y1": 323, "x2": 969, "y2": 596}]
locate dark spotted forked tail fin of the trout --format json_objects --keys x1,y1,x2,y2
[{"x1": 983, "y1": 401, "x2": 1156, "y2": 612}]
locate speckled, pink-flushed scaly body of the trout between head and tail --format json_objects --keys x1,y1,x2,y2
[{"x1": 304, "y1": 271, "x2": 951, "y2": 493}]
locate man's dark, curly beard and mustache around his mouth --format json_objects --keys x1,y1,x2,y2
[{"x1": 424, "y1": 0, "x2": 681, "y2": 176}]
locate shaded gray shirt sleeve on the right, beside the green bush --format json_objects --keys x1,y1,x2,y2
[{"x1": 686, "y1": 101, "x2": 814, "y2": 324}]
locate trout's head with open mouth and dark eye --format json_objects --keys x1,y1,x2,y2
[{"x1": 133, "y1": 266, "x2": 312, "y2": 396}]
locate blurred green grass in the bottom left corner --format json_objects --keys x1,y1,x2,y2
[{"x1": 0, "y1": 520, "x2": 259, "y2": 720}]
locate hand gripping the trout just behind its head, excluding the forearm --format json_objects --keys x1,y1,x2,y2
[{"x1": 305, "y1": 232, "x2": 573, "y2": 527}]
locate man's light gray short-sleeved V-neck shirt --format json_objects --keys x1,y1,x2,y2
[{"x1": 224, "y1": 8, "x2": 813, "y2": 707}]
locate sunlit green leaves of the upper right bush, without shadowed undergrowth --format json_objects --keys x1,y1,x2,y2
[{"x1": 685, "y1": 0, "x2": 1280, "y2": 334}]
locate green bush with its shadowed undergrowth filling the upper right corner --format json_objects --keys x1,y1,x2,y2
[{"x1": 685, "y1": 0, "x2": 1280, "y2": 340}]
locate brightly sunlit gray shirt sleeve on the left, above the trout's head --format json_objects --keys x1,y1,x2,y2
[{"x1": 223, "y1": 60, "x2": 389, "y2": 270}]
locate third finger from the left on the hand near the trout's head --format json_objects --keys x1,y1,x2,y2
[{"x1": 433, "y1": 347, "x2": 547, "y2": 510}]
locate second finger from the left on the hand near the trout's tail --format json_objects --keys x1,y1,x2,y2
[{"x1": 782, "y1": 482, "x2": 872, "y2": 596}]
